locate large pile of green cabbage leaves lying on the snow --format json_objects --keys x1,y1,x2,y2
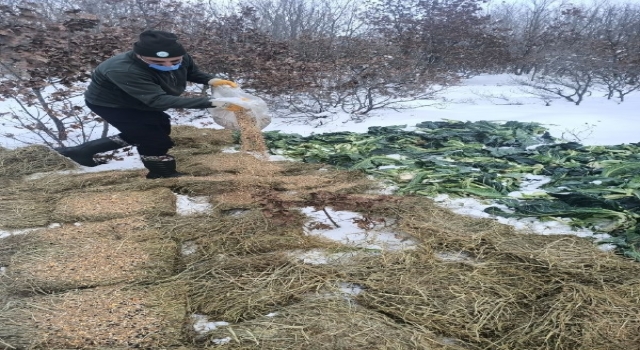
[{"x1": 264, "y1": 121, "x2": 640, "y2": 260}]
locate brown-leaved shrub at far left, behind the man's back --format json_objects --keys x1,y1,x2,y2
[{"x1": 0, "y1": 2, "x2": 135, "y2": 146}]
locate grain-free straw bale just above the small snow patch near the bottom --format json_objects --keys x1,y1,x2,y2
[{"x1": 180, "y1": 253, "x2": 337, "y2": 322}]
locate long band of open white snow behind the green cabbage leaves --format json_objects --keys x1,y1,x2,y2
[{"x1": 265, "y1": 75, "x2": 640, "y2": 145}]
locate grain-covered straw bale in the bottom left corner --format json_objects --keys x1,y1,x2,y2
[{"x1": 0, "y1": 285, "x2": 185, "y2": 349}]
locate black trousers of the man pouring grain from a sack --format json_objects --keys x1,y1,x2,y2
[{"x1": 85, "y1": 101, "x2": 174, "y2": 156}]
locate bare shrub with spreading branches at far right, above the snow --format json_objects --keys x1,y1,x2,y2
[{"x1": 492, "y1": 0, "x2": 640, "y2": 104}]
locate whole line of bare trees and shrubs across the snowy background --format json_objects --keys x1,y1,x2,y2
[{"x1": 5, "y1": 0, "x2": 640, "y2": 145}]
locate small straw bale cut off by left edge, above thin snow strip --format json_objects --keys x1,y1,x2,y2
[{"x1": 0, "y1": 195, "x2": 53, "y2": 229}]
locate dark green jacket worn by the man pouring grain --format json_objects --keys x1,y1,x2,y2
[{"x1": 84, "y1": 51, "x2": 213, "y2": 111}]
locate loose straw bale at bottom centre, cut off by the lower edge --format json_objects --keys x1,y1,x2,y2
[{"x1": 200, "y1": 295, "x2": 462, "y2": 350}]
